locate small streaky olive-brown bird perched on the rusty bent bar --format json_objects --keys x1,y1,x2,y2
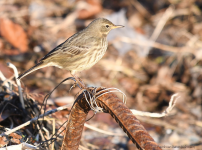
[{"x1": 18, "y1": 18, "x2": 124, "y2": 87}]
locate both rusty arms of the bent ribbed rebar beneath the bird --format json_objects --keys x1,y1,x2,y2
[{"x1": 62, "y1": 90, "x2": 161, "y2": 150}]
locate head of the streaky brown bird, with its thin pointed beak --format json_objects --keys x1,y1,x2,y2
[{"x1": 89, "y1": 18, "x2": 124, "y2": 35}]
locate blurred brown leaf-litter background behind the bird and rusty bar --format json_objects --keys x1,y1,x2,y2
[{"x1": 0, "y1": 0, "x2": 202, "y2": 150}]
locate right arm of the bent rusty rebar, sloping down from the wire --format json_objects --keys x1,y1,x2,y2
[{"x1": 97, "y1": 90, "x2": 161, "y2": 150}]
